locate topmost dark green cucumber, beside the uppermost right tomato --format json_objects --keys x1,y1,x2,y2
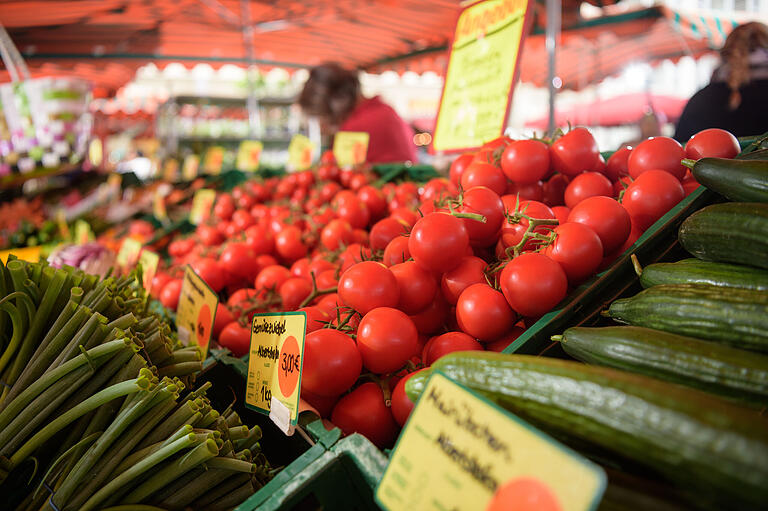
[{"x1": 691, "y1": 158, "x2": 768, "y2": 203}]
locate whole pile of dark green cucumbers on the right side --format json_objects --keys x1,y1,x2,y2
[{"x1": 406, "y1": 160, "x2": 768, "y2": 510}]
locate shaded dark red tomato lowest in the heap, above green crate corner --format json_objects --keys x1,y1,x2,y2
[{"x1": 331, "y1": 382, "x2": 397, "y2": 449}]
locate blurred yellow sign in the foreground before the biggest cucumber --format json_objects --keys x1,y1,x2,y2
[{"x1": 376, "y1": 372, "x2": 606, "y2": 511}]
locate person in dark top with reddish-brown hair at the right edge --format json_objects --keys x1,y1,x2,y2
[{"x1": 674, "y1": 22, "x2": 768, "y2": 144}]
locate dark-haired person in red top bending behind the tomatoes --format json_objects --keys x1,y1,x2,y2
[{"x1": 299, "y1": 63, "x2": 416, "y2": 163}]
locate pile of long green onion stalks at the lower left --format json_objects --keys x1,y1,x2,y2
[{"x1": 0, "y1": 259, "x2": 274, "y2": 511}]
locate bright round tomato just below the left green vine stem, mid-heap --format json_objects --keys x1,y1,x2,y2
[{"x1": 408, "y1": 213, "x2": 469, "y2": 273}]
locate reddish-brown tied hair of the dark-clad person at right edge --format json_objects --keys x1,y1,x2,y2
[{"x1": 720, "y1": 21, "x2": 768, "y2": 110}]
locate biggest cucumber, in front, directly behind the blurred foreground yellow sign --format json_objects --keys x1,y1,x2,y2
[{"x1": 406, "y1": 351, "x2": 768, "y2": 510}]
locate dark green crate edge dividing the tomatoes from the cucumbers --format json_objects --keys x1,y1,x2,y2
[{"x1": 503, "y1": 186, "x2": 717, "y2": 355}]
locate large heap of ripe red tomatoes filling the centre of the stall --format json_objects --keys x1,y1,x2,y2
[{"x1": 147, "y1": 128, "x2": 738, "y2": 447}]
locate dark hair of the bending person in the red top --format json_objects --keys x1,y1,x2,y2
[{"x1": 299, "y1": 63, "x2": 360, "y2": 125}]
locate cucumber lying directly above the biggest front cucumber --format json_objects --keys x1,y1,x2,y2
[{"x1": 553, "y1": 326, "x2": 768, "y2": 407}]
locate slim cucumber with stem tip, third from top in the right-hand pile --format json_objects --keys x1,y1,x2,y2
[{"x1": 640, "y1": 258, "x2": 768, "y2": 291}]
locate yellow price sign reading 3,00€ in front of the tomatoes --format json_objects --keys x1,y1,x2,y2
[{"x1": 245, "y1": 312, "x2": 307, "y2": 435}]
